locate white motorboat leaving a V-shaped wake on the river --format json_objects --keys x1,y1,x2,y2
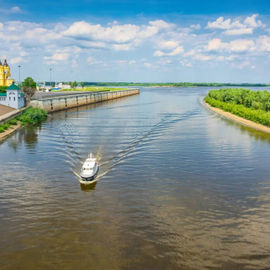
[{"x1": 80, "y1": 153, "x2": 99, "y2": 184}]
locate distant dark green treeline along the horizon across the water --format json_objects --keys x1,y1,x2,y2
[{"x1": 61, "y1": 82, "x2": 270, "y2": 87}]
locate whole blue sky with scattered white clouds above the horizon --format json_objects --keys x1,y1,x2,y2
[{"x1": 0, "y1": 0, "x2": 270, "y2": 83}]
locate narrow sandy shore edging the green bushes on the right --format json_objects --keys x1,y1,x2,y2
[{"x1": 204, "y1": 102, "x2": 270, "y2": 134}]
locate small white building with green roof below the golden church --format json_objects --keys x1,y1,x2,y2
[{"x1": 0, "y1": 83, "x2": 25, "y2": 109}]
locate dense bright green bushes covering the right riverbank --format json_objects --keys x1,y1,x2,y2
[{"x1": 204, "y1": 89, "x2": 270, "y2": 126}]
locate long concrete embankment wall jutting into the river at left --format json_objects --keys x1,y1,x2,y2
[{"x1": 30, "y1": 89, "x2": 140, "y2": 112}]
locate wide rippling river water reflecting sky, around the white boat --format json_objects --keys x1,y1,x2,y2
[{"x1": 0, "y1": 88, "x2": 270, "y2": 270}]
